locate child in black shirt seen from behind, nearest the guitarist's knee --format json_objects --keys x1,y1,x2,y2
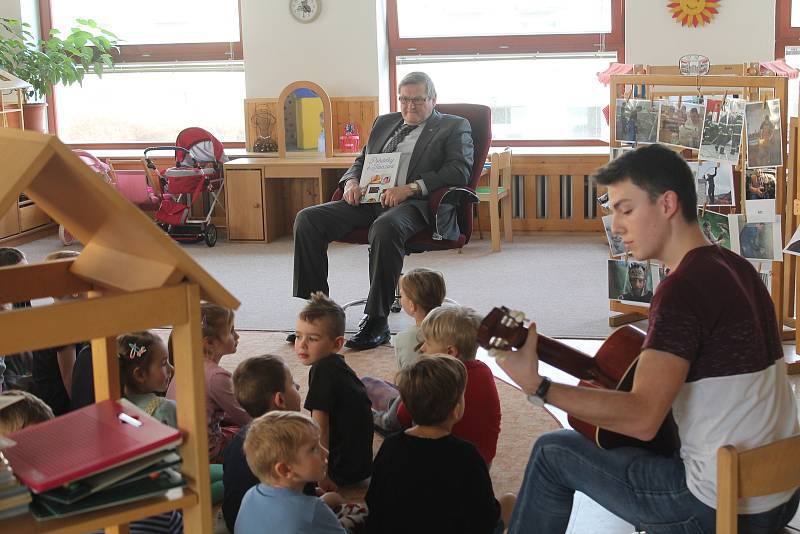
[{"x1": 366, "y1": 354, "x2": 515, "y2": 534}]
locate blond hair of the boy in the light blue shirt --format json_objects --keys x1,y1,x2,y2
[{"x1": 244, "y1": 410, "x2": 319, "y2": 484}]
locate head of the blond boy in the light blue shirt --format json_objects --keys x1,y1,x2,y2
[{"x1": 244, "y1": 411, "x2": 328, "y2": 486}]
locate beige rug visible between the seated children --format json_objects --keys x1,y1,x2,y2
[{"x1": 216, "y1": 332, "x2": 559, "y2": 499}]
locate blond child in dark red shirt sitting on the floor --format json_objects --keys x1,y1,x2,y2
[{"x1": 397, "y1": 306, "x2": 500, "y2": 467}]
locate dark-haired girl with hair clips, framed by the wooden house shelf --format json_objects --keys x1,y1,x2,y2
[{"x1": 117, "y1": 331, "x2": 178, "y2": 428}]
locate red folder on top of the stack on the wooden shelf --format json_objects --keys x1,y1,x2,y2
[{"x1": 3, "y1": 399, "x2": 181, "y2": 493}]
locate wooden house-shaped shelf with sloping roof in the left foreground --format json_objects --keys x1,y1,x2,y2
[{"x1": 0, "y1": 130, "x2": 239, "y2": 534}]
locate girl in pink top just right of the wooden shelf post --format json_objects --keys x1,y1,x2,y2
[{"x1": 167, "y1": 302, "x2": 251, "y2": 464}]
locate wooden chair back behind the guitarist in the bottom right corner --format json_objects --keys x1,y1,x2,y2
[{"x1": 717, "y1": 434, "x2": 800, "y2": 534}]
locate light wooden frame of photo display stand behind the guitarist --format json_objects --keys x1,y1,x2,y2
[{"x1": 608, "y1": 63, "x2": 800, "y2": 360}]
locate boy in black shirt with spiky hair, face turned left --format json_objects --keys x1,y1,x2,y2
[{"x1": 294, "y1": 292, "x2": 372, "y2": 491}]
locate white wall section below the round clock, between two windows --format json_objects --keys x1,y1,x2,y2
[{"x1": 241, "y1": 0, "x2": 385, "y2": 98}]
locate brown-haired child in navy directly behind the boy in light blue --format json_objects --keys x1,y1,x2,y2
[{"x1": 222, "y1": 355, "x2": 300, "y2": 532}]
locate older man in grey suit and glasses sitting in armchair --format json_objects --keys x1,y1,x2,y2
[{"x1": 287, "y1": 72, "x2": 473, "y2": 350}]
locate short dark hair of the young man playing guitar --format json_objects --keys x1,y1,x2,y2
[{"x1": 594, "y1": 144, "x2": 697, "y2": 222}]
